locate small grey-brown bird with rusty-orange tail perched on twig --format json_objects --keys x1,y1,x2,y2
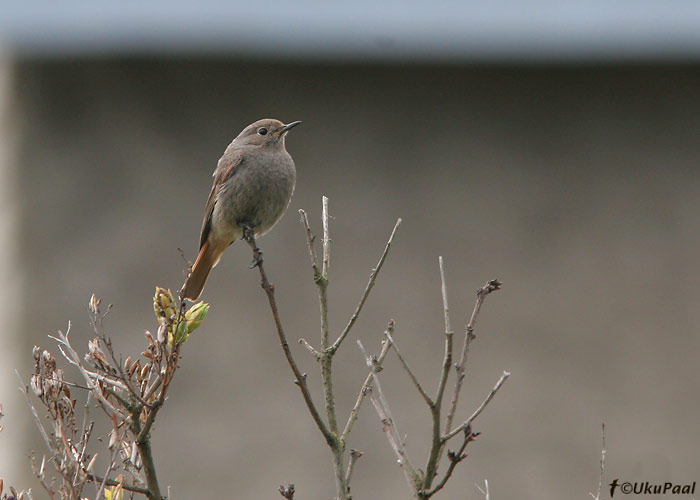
[{"x1": 180, "y1": 118, "x2": 301, "y2": 301}]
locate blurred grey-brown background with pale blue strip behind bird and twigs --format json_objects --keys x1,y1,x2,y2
[{"x1": 0, "y1": 0, "x2": 700, "y2": 499}]
